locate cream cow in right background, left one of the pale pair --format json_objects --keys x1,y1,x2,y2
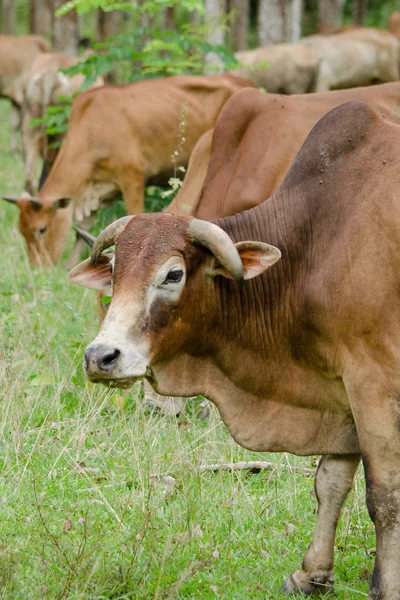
[{"x1": 233, "y1": 44, "x2": 320, "y2": 94}]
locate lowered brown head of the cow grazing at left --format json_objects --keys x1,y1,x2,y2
[{"x1": 3, "y1": 193, "x2": 72, "y2": 267}]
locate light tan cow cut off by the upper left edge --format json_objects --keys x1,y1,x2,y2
[{"x1": 0, "y1": 35, "x2": 51, "y2": 152}]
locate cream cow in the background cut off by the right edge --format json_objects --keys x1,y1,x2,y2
[{"x1": 300, "y1": 27, "x2": 400, "y2": 92}]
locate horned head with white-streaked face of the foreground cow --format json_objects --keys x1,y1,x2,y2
[{"x1": 70, "y1": 214, "x2": 280, "y2": 391}]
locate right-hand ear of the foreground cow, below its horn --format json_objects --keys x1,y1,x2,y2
[{"x1": 215, "y1": 242, "x2": 281, "y2": 279}]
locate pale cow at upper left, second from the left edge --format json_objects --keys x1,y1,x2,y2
[{"x1": 22, "y1": 53, "x2": 103, "y2": 194}]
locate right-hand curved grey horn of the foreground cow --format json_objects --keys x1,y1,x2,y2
[{"x1": 187, "y1": 219, "x2": 244, "y2": 284}]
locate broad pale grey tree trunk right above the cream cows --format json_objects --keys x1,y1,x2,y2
[{"x1": 257, "y1": 0, "x2": 302, "y2": 46}]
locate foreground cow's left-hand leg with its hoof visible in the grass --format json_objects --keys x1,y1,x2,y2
[{"x1": 282, "y1": 454, "x2": 360, "y2": 595}]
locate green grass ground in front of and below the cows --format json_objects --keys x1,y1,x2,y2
[{"x1": 0, "y1": 101, "x2": 375, "y2": 600}]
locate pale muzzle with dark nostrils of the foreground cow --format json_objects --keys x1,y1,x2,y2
[{"x1": 84, "y1": 343, "x2": 148, "y2": 388}]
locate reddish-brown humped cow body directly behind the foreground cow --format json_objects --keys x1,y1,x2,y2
[{"x1": 185, "y1": 83, "x2": 400, "y2": 220}]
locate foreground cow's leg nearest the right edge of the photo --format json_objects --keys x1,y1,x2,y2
[{"x1": 344, "y1": 360, "x2": 400, "y2": 600}]
